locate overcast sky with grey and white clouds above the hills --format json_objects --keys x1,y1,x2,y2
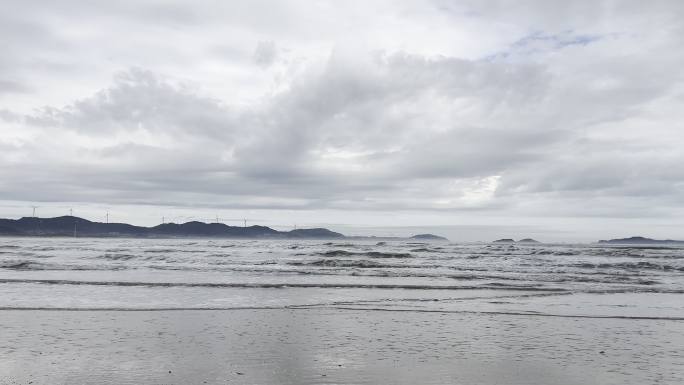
[{"x1": 0, "y1": 0, "x2": 684, "y2": 242}]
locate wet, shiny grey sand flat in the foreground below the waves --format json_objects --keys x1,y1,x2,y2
[{"x1": 0, "y1": 309, "x2": 684, "y2": 385}]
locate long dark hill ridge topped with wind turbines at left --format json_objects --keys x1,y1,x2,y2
[{"x1": 0, "y1": 216, "x2": 344, "y2": 239}]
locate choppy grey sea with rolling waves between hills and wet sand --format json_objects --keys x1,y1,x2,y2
[{"x1": 0, "y1": 238, "x2": 684, "y2": 318}]
